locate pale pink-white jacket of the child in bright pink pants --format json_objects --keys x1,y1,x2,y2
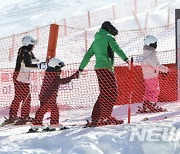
[{"x1": 141, "y1": 46, "x2": 169, "y2": 79}]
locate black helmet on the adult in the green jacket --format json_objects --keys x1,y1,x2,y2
[{"x1": 101, "y1": 21, "x2": 118, "y2": 36}]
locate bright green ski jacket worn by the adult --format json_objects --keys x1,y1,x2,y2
[{"x1": 79, "y1": 28, "x2": 128, "y2": 71}]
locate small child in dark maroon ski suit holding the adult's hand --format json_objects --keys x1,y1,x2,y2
[{"x1": 29, "y1": 58, "x2": 78, "y2": 132}]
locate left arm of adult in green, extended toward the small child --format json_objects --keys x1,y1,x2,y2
[{"x1": 79, "y1": 45, "x2": 94, "y2": 71}]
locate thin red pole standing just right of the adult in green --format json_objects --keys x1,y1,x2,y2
[{"x1": 128, "y1": 57, "x2": 133, "y2": 124}]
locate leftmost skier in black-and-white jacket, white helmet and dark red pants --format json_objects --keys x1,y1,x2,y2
[{"x1": 4, "y1": 36, "x2": 46, "y2": 124}]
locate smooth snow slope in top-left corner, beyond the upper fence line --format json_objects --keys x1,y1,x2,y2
[{"x1": 0, "y1": 0, "x2": 127, "y2": 37}]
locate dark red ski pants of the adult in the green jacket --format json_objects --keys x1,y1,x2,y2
[{"x1": 91, "y1": 69, "x2": 117, "y2": 122}]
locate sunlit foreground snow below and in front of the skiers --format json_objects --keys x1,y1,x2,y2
[{"x1": 0, "y1": 103, "x2": 180, "y2": 154}]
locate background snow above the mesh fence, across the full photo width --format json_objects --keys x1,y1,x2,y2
[{"x1": 0, "y1": 0, "x2": 180, "y2": 38}]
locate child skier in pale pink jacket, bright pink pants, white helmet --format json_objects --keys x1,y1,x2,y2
[{"x1": 138, "y1": 35, "x2": 169, "y2": 113}]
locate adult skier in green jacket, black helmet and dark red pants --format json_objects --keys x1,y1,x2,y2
[{"x1": 77, "y1": 21, "x2": 128, "y2": 127}]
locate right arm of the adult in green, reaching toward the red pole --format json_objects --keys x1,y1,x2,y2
[{"x1": 107, "y1": 35, "x2": 128, "y2": 62}]
